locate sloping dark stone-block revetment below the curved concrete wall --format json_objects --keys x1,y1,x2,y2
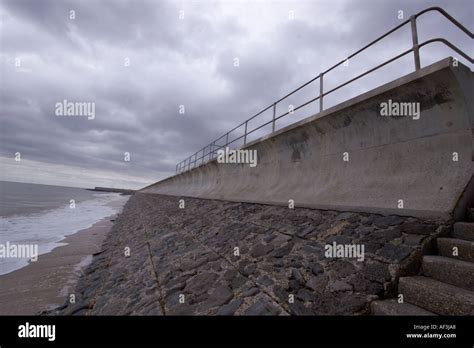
[{"x1": 57, "y1": 193, "x2": 439, "y2": 315}]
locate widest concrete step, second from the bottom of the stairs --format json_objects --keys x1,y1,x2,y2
[{"x1": 398, "y1": 276, "x2": 474, "y2": 315}]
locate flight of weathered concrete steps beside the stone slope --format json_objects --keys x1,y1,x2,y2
[{"x1": 371, "y1": 209, "x2": 474, "y2": 315}]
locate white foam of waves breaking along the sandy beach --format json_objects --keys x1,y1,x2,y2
[{"x1": 0, "y1": 193, "x2": 128, "y2": 275}]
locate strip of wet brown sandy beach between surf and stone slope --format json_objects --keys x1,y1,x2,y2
[{"x1": 0, "y1": 197, "x2": 127, "y2": 315}]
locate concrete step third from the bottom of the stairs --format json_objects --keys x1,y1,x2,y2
[{"x1": 422, "y1": 255, "x2": 474, "y2": 291}]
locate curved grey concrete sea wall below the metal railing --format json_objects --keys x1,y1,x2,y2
[{"x1": 142, "y1": 59, "x2": 474, "y2": 219}]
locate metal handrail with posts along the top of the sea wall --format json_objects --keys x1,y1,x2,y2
[{"x1": 176, "y1": 7, "x2": 474, "y2": 173}]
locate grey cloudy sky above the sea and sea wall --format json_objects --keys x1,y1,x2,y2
[{"x1": 0, "y1": 0, "x2": 474, "y2": 188}]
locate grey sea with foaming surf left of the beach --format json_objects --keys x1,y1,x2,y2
[{"x1": 0, "y1": 181, "x2": 128, "y2": 275}]
